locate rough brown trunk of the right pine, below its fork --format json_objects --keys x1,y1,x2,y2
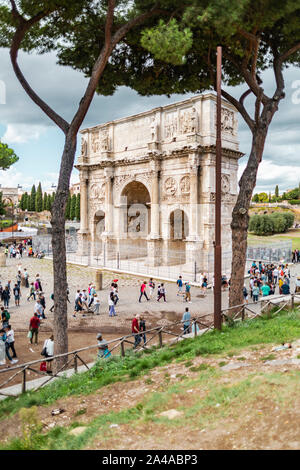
[{"x1": 229, "y1": 125, "x2": 268, "y2": 307}]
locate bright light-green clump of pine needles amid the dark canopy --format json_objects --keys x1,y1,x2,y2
[{"x1": 141, "y1": 19, "x2": 193, "y2": 65}]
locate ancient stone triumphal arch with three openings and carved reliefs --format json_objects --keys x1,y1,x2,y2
[{"x1": 76, "y1": 93, "x2": 242, "y2": 271}]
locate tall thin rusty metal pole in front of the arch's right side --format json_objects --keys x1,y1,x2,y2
[{"x1": 214, "y1": 46, "x2": 222, "y2": 330}]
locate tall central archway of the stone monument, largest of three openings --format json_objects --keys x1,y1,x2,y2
[{"x1": 120, "y1": 181, "x2": 151, "y2": 258}]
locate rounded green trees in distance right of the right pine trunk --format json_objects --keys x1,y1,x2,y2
[{"x1": 249, "y1": 212, "x2": 295, "y2": 235}]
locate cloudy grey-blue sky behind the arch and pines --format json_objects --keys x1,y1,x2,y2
[{"x1": 0, "y1": 49, "x2": 300, "y2": 193}]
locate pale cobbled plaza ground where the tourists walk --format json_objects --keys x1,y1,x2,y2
[{"x1": 0, "y1": 257, "x2": 300, "y2": 335}]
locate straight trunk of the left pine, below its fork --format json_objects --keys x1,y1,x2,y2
[{"x1": 51, "y1": 135, "x2": 76, "y2": 368}]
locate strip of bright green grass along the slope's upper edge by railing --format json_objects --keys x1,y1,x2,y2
[{"x1": 0, "y1": 310, "x2": 300, "y2": 418}]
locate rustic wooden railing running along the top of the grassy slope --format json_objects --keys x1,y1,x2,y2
[{"x1": 0, "y1": 294, "x2": 300, "y2": 396}]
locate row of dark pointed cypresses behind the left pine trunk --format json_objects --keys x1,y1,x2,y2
[{"x1": 19, "y1": 183, "x2": 80, "y2": 220}]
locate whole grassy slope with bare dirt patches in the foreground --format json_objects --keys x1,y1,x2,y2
[{"x1": 0, "y1": 309, "x2": 300, "y2": 449}]
